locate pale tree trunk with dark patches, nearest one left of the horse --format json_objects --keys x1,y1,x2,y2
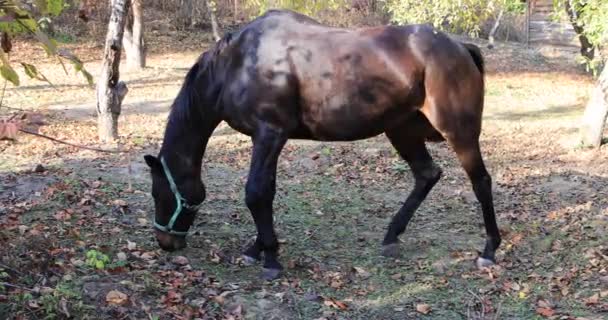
[{"x1": 97, "y1": 0, "x2": 130, "y2": 142}]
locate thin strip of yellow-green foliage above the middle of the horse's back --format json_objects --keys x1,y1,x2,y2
[{"x1": 247, "y1": 0, "x2": 348, "y2": 16}]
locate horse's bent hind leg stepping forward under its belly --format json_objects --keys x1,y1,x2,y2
[{"x1": 382, "y1": 126, "x2": 441, "y2": 257}]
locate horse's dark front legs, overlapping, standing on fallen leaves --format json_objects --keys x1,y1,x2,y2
[{"x1": 244, "y1": 126, "x2": 287, "y2": 280}]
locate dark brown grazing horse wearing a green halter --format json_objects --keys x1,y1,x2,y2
[{"x1": 144, "y1": 10, "x2": 500, "y2": 279}]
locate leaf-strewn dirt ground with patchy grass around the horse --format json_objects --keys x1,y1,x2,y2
[{"x1": 0, "y1": 28, "x2": 608, "y2": 320}]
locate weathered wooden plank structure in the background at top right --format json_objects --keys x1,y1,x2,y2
[{"x1": 526, "y1": 0, "x2": 580, "y2": 50}]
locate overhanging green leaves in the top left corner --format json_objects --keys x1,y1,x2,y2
[{"x1": 0, "y1": 0, "x2": 93, "y2": 86}]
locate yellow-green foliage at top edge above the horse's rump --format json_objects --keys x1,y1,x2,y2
[{"x1": 384, "y1": 0, "x2": 525, "y2": 36}]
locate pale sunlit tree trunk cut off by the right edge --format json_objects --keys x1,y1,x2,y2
[{"x1": 582, "y1": 62, "x2": 608, "y2": 147}]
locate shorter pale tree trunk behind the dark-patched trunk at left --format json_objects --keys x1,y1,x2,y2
[{"x1": 122, "y1": 0, "x2": 146, "y2": 70}]
